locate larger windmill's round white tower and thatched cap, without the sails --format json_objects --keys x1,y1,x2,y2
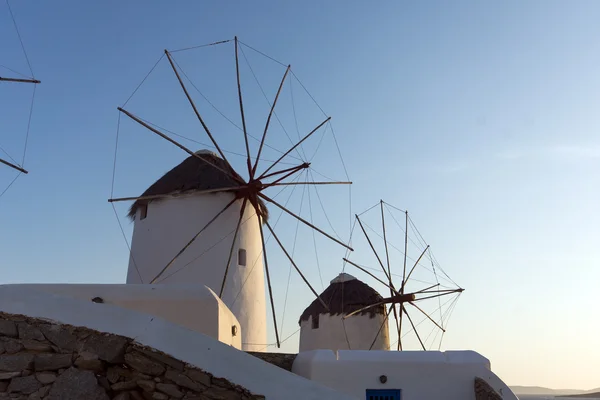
[{"x1": 127, "y1": 151, "x2": 267, "y2": 351}]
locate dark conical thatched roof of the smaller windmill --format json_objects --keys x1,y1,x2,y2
[{"x1": 298, "y1": 273, "x2": 386, "y2": 323}]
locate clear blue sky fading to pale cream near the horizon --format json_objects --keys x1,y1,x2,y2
[{"x1": 0, "y1": 1, "x2": 600, "y2": 388}]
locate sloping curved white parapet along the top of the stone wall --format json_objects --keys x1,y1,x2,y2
[{"x1": 0, "y1": 285, "x2": 353, "y2": 400}]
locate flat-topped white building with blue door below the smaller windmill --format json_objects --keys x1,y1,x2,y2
[{"x1": 292, "y1": 350, "x2": 517, "y2": 400}]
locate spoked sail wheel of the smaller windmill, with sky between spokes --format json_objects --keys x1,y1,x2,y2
[{"x1": 342, "y1": 200, "x2": 464, "y2": 350}]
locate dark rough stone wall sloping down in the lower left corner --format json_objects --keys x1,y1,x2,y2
[{"x1": 0, "y1": 313, "x2": 264, "y2": 400}]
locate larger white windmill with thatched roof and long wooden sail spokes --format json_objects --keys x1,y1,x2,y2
[{"x1": 109, "y1": 38, "x2": 351, "y2": 351}]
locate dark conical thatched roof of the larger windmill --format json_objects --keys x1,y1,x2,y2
[{"x1": 128, "y1": 150, "x2": 268, "y2": 219}]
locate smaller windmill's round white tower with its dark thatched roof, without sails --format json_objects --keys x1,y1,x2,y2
[{"x1": 300, "y1": 273, "x2": 390, "y2": 352}]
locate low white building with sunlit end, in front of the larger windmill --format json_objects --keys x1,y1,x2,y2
[{"x1": 0, "y1": 284, "x2": 242, "y2": 349}]
